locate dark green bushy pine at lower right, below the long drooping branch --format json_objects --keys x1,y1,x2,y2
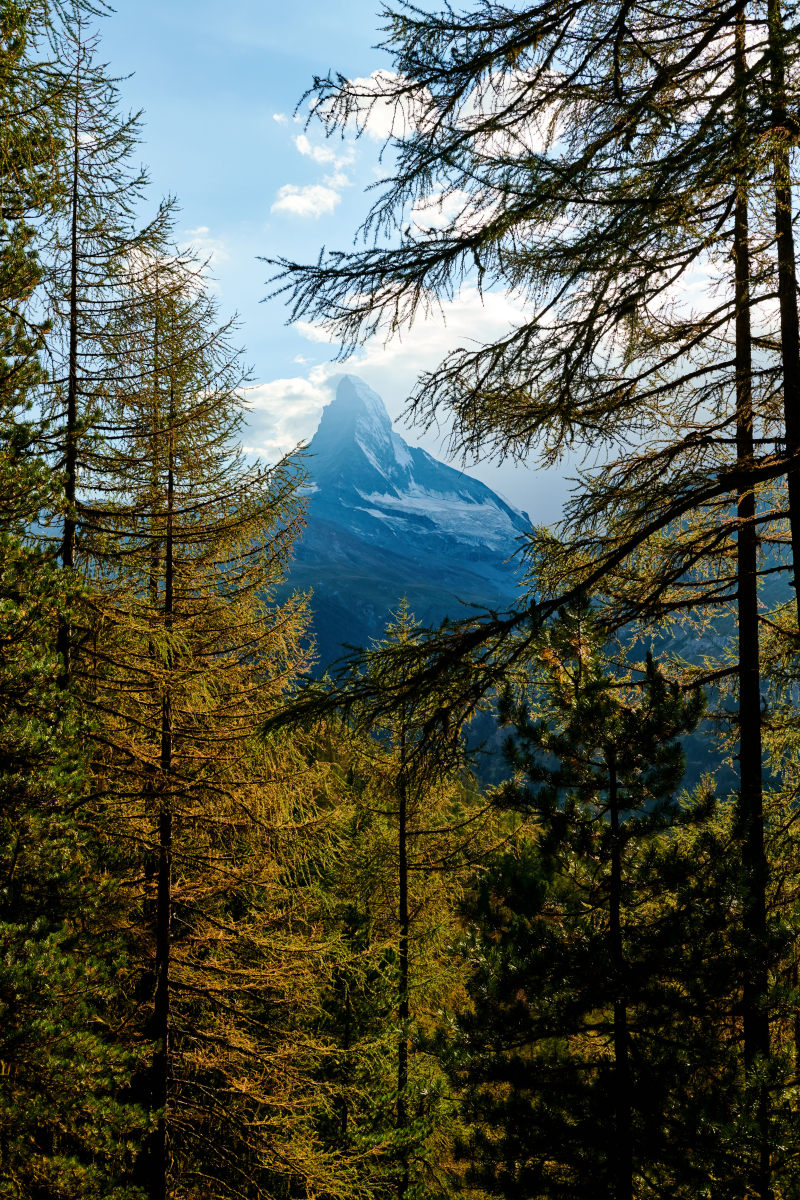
[{"x1": 456, "y1": 612, "x2": 743, "y2": 1200}]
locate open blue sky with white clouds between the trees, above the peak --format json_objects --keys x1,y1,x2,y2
[{"x1": 102, "y1": 0, "x2": 565, "y2": 521}]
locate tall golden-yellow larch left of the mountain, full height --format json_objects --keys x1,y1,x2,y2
[{"x1": 76, "y1": 256, "x2": 352, "y2": 1198}]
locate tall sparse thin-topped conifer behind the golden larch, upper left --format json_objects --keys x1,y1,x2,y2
[{"x1": 40, "y1": 4, "x2": 172, "y2": 680}]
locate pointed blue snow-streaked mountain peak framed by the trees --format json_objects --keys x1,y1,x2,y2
[{"x1": 289, "y1": 376, "x2": 530, "y2": 665}]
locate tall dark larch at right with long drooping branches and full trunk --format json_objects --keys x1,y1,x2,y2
[{"x1": 267, "y1": 18, "x2": 800, "y2": 1200}]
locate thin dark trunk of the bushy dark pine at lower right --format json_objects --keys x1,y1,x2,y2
[{"x1": 608, "y1": 750, "x2": 633, "y2": 1200}]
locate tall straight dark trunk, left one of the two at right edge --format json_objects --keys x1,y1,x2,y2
[{"x1": 734, "y1": 14, "x2": 772, "y2": 1200}]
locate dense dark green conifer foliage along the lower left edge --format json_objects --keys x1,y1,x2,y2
[{"x1": 0, "y1": 534, "x2": 142, "y2": 1200}]
